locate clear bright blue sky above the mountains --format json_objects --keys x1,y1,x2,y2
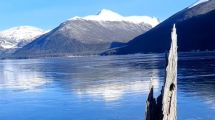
[{"x1": 0, "y1": 0, "x2": 196, "y2": 30}]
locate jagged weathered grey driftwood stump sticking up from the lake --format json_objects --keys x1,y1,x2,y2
[{"x1": 146, "y1": 25, "x2": 178, "y2": 120}]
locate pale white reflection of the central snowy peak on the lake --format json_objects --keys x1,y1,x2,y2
[{"x1": 76, "y1": 78, "x2": 159, "y2": 102}]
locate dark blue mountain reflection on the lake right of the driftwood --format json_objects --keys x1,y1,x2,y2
[{"x1": 178, "y1": 55, "x2": 215, "y2": 112}]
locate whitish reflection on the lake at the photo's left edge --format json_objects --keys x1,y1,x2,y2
[{"x1": 0, "y1": 61, "x2": 47, "y2": 90}]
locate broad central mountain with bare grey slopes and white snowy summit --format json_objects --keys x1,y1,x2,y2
[{"x1": 14, "y1": 10, "x2": 159, "y2": 58}]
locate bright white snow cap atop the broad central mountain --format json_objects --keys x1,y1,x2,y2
[{"x1": 69, "y1": 9, "x2": 159, "y2": 27}]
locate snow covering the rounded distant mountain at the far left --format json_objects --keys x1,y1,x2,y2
[{"x1": 0, "y1": 26, "x2": 45, "y2": 49}]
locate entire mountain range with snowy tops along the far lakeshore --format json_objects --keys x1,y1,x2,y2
[{"x1": 0, "y1": 0, "x2": 215, "y2": 58}]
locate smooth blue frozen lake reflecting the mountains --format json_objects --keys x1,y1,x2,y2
[{"x1": 0, "y1": 53, "x2": 215, "y2": 120}]
